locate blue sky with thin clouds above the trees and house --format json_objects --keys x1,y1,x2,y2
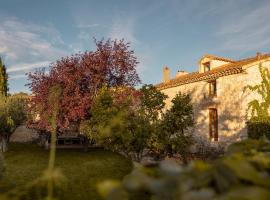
[{"x1": 0, "y1": 0, "x2": 270, "y2": 93}]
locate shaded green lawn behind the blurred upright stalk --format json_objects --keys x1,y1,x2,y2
[{"x1": 1, "y1": 144, "x2": 132, "y2": 200}]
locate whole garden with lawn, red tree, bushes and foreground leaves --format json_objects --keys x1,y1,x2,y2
[{"x1": 0, "y1": 39, "x2": 270, "y2": 200}]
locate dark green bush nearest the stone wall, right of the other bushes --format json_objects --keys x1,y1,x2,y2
[{"x1": 154, "y1": 93, "x2": 193, "y2": 162}]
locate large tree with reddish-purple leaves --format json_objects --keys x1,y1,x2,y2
[{"x1": 28, "y1": 39, "x2": 140, "y2": 130}]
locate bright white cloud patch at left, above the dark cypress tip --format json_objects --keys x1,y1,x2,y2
[{"x1": 0, "y1": 18, "x2": 66, "y2": 64}]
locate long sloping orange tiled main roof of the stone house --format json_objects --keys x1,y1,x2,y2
[{"x1": 156, "y1": 54, "x2": 270, "y2": 89}]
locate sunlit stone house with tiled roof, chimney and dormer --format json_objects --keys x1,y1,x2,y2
[{"x1": 156, "y1": 53, "x2": 270, "y2": 144}]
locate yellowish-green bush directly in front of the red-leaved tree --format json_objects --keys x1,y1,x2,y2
[{"x1": 81, "y1": 87, "x2": 150, "y2": 161}]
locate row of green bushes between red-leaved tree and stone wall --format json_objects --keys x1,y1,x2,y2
[{"x1": 81, "y1": 85, "x2": 193, "y2": 161}]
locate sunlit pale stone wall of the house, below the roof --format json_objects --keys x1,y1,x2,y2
[{"x1": 162, "y1": 61, "x2": 270, "y2": 145}]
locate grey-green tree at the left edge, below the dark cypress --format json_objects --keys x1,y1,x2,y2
[{"x1": 0, "y1": 96, "x2": 26, "y2": 152}]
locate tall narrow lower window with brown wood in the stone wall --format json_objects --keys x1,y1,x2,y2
[{"x1": 209, "y1": 108, "x2": 218, "y2": 141}]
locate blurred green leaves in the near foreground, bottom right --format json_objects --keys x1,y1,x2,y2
[{"x1": 99, "y1": 140, "x2": 270, "y2": 200}]
